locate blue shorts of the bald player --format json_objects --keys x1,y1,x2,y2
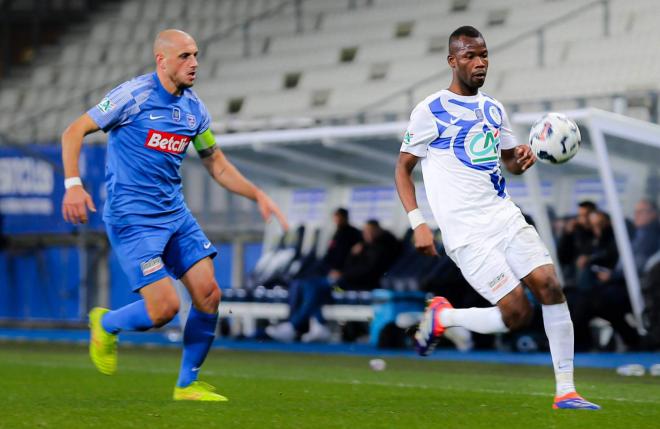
[{"x1": 106, "y1": 213, "x2": 218, "y2": 292}]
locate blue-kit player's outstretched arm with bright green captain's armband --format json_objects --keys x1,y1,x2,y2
[{"x1": 193, "y1": 129, "x2": 289, "y2": 230}]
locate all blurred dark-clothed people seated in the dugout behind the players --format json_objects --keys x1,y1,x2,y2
[{"x1": 266, "y1": 199, "x2": 660, "y2": 351}]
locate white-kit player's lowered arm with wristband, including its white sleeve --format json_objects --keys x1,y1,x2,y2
[{"x1": 394, "y1": 104, "x2": 438, "y2": 256}]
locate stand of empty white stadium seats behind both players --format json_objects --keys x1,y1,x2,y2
[{"x1": 0, "y1": 0, "x2": 660, "y2": 139}]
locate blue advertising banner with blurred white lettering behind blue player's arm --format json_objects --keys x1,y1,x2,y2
[{"x1": 0, "y1": 145, "x2": 105, "y2": 235}]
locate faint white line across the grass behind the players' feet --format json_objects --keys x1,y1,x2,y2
[{"x1": 5, "y1": 361, "x2": 660, "y2": 405}]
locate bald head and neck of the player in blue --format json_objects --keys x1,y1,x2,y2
[{"x1": 154, "y1": 29, "x2": 197, "y2": 95}]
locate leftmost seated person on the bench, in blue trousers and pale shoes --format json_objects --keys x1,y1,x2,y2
[{"x1": 266, "y1": 207, "x2": 362, "y2": 342}]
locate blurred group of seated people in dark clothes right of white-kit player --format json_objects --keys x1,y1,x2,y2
[{"x1": 555, "y1": 199, "x2": 660, "y2": 350}]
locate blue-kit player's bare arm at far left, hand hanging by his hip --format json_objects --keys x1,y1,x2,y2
[{"x1": 62, "y1": 113, "x2": 100, "y2": 224}]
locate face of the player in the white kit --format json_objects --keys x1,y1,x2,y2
[{"x1": 448, "y1": 36, "x2": 488, "y2": 89}]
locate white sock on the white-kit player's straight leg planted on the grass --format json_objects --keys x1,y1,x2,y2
[{"x1": 541, "y1": 302, "x2": 575, "y2": 396}]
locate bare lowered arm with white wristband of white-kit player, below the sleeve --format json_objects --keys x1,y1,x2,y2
[{"x1": 394, "y1": 152, "x2": 438, "y2": 256}]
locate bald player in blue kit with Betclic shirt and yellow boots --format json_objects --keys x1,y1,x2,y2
[{"x1": 62, "y1": 30, "x2": 288, "y2": 401}]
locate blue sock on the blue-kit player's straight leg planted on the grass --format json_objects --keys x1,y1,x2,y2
[{"x1": 176, "y1": 306, "x2": 218, "y2": 387}]
